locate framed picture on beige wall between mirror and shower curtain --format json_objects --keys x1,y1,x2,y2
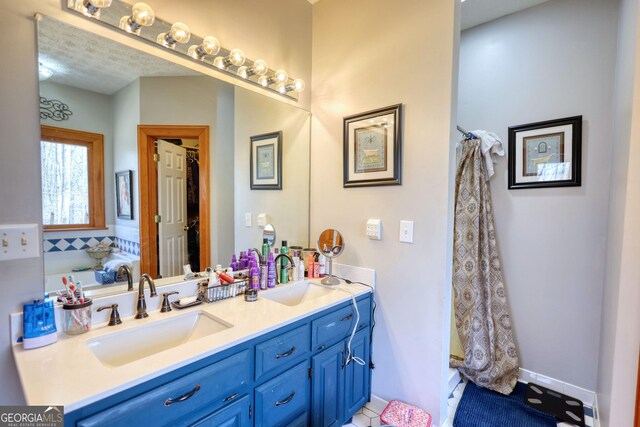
[{"x1": 343, "y1": 104, "x2": 402, "y2": 187}]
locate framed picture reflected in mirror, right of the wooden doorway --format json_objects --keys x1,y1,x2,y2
[{"x1": 249, "y1": 131, "x2": 282, "y2": 190}]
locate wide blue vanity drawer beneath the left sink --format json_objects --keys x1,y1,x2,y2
[{"x1": 78, "y1": 350, "x2": 251, "y2": 427}]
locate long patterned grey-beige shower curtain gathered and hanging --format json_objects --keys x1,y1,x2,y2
[{"x1": 450, "y1": 139, "x2": 519, "y2": 394}]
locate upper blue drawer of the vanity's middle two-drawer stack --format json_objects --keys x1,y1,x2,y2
[{"x1": 256, "y1": 324, "x2": 311, "y2": 381}]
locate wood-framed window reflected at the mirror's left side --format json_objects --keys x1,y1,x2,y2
[{"x1": 40, "y1": 125, "x2": 105, "y2": 230}]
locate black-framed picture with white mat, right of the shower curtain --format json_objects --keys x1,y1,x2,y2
[{"x1": 509, "y1": 116, "x2": 582, "y2": 190}]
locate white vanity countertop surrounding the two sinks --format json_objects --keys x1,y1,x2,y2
[{"x1": 12, "y1": 280, "x2": 371, "y2": 413}]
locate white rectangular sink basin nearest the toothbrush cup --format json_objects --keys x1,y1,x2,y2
[{"x1": 87, "y1": 311, "x2": 233, "y2": 366}]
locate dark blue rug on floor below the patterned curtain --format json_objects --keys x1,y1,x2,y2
[{"x1": 453, "y1": 381, "x2": 558, "y2": 427}]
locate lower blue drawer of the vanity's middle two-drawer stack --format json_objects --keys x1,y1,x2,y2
[{"x1": 255, "y1": 361, "x2": 310, "y2": 427}]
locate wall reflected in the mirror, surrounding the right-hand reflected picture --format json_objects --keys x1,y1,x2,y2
[{"x1": 234, "y1": 88, "x2": 311, "y2": 251}]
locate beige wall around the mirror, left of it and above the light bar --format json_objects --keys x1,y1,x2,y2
[{"x1": 0, "y1": 0, "x2": 311, "y2": 405}]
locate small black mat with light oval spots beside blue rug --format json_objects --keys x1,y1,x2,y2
[{"x1": 525, "y1": 383, "x2": 585, "y2": 427}]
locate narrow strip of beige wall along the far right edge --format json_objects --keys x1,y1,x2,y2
[{"x1": 597, "y1": 0, "x2": 640, "y2": 427}]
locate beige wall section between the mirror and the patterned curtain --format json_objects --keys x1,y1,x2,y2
[{"x1": 311, "y1": 0, "x2": 455, "y2": 422}]
